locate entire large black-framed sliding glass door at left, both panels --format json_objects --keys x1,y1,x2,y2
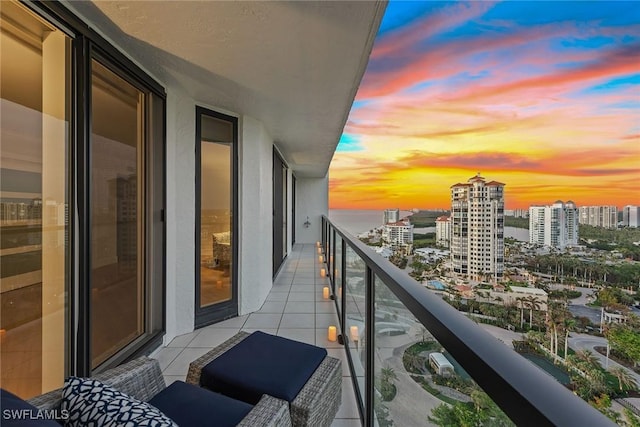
[{"x1": 0, "y1": 0, "x2": 166, "y2": 398}]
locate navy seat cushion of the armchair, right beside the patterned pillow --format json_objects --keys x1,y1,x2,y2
[{"x1": 149, "y1": 381, "x2": 253, "y2": 427}]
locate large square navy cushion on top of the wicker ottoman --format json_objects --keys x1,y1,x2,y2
[{"x1": 200, "y1": 331, "x2": 327, "y2": 404}]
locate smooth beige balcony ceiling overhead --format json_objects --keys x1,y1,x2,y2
[{"x1": 66, "y1": 1, "x2": 386, "y2": 177}]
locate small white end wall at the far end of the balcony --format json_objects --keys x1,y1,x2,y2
[{"x1": 296, "y1": 176, "x2": 329, "y2": 243}]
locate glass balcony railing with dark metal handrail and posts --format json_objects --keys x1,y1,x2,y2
[{"x1": 322, "y1": 217, "x2": 614, "y2": 426}]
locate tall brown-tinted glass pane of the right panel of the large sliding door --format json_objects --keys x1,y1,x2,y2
[{"x1": 90, "y1": 59, "x2": 145, "y2": 368}]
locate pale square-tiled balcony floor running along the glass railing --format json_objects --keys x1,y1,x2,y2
[{"x1": 151, "y1": 245, "x2": 361, "y2": 427}]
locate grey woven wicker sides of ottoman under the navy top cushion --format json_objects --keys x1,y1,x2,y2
[{"x1": 186, "y1": 331, "x2": 342, "y2": 427}]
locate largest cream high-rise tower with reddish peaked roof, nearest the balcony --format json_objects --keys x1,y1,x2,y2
[{"x1": 450, "y1": 173, "x2": 505, "y2": 280}]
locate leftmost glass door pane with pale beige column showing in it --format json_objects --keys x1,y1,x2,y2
[{"x1": 0, "y1": 1, "x2": 71, "y2": 398}]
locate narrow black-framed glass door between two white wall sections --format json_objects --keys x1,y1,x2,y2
[{"x1": 196, "y1": 108, "x2": 238, "y2": 327}]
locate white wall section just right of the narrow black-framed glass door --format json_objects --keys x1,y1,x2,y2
[{"x1": 238, "y1": 116, "x2": 273, "y2": 315}]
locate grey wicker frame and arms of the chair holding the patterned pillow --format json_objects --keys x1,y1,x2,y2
[{"x1": 29, "y1": 356, "x2": 291, "y2": 427}]
